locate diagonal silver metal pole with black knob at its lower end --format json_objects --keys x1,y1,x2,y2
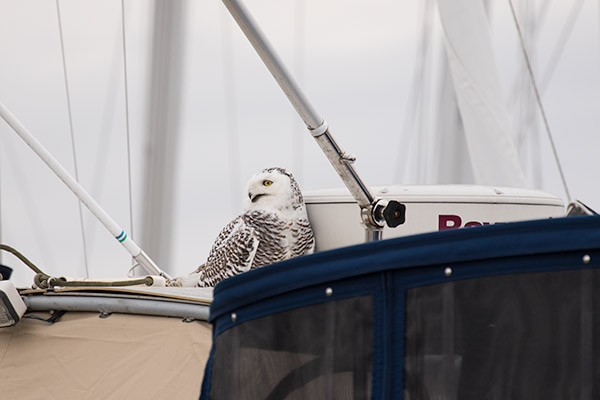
[{"x1": 223, "y1": 0, "x2": 405, "y2": 241}]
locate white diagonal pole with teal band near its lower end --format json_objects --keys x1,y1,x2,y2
[{"x1": 0, "y1": 103, "x2": 171, "y2": 279}]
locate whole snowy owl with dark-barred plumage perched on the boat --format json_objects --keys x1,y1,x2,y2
[{"x1": 169, "y1": 167, "x2": 315, "y2": 287}]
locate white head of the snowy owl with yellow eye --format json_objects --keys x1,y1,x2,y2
[{"x1": 246, "y1": 167, "x2": 304, "y2": 211}]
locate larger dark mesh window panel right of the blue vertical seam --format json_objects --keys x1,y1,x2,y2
[{"x1": 404, "y1": 270, "x2": 600, "y2": 400}]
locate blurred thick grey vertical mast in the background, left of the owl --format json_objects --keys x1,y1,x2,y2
[{"x1": 141, "y1": 1, "x2": 186, "y2": 271}]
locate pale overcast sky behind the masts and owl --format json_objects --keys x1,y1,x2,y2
[{"x1": 0, "y1": 0, "x2": 600, "y2": 286}]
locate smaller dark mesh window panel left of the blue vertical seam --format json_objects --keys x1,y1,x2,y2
[{"x1": 210, "y1": 296, "x2": 373, "y2": 400}]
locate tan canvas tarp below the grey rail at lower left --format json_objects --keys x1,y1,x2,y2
[{"x1": 0, "y1": 312, "x2": 212, "y2": 400}]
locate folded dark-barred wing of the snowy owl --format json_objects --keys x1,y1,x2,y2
[{"x1": 198, "y1": 216, "x2": 259, "y2": 286}]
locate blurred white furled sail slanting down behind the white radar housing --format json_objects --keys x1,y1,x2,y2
[{"x1": 438, "y1": 0, "x2": 525, "y2": 187}]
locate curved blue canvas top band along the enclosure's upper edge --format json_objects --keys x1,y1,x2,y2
[{"x1": 210, "y1": 216, "x2": 600, "y2": 321}]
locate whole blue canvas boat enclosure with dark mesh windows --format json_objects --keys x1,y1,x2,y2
[{"x1": 201, "y1": 216, "x2": 600, "y2": 399}]
